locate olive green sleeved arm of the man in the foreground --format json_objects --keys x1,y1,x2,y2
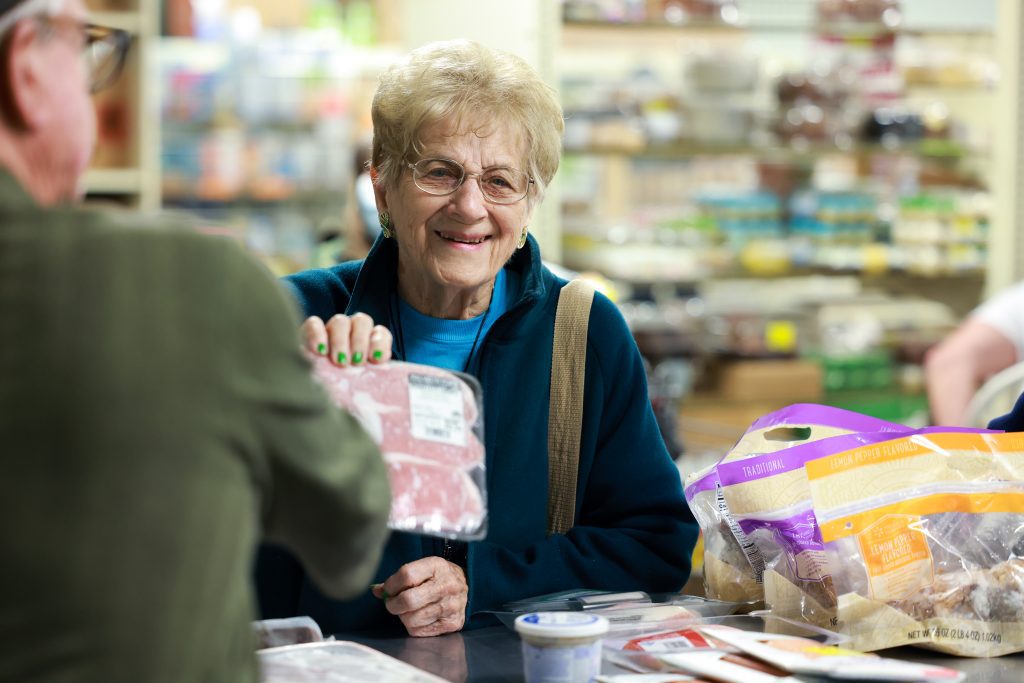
[{"x1": 223, "y1": 241, "x2": 391, "y2": 598}]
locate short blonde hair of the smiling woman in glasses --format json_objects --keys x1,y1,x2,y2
[{"x1": 371, "y1": 40, "x2": 564, "y2": 199}]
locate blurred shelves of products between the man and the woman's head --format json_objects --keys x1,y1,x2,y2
[{"x1": 159, "y1": 22, "x2": 401, "y2": 273}]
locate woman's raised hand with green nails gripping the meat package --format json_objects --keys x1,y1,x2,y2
[{"x1": 301, "y1": 313, "x2": 391, "y2": 366}]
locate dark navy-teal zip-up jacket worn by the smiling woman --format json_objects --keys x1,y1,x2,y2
[{"x1": 257, "y1": 237, "x2": 697, "y2": 634}]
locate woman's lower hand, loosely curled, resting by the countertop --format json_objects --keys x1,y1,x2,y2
[{"x1": 373, "y1": 557, "x2": 469, "y2": 636}]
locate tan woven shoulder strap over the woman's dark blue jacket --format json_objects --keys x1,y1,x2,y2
[{"x1": 548, "y1": 280, "x2": 594, "y2": 536}]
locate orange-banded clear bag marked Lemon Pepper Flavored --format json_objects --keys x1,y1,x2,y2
[{"x1": 805, "y1": 432, "x2": 1024, "y2": 656}]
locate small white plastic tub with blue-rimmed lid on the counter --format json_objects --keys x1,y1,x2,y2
[{"x1": 515, "y1": 611, "x2": 608, "y2": 683}]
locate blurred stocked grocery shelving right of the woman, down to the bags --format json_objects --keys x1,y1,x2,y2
[{"x1": 559, "y1": 0, "x2": 998, "y2": 454}]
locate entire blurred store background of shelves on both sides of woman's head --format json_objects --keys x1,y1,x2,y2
[{"x1": 79, "y1": 0, "x2": 1007, "y2": 468}]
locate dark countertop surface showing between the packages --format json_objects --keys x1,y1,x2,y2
[{"x1": 344, "y1": 626, "x2": 1024, "y2": 683}]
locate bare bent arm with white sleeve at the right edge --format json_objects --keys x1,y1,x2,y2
[{"x1": 925, "y1": 285, "x2": 1024, "y2": 425}]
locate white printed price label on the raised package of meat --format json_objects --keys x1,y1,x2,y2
[{"x1": 409, "y1": 375, "x2": 466, "y2": 445}]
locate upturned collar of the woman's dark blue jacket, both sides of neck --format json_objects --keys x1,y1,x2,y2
[{"x1": 345, "y1": 234, "x2": 554, "y2": 327}]
